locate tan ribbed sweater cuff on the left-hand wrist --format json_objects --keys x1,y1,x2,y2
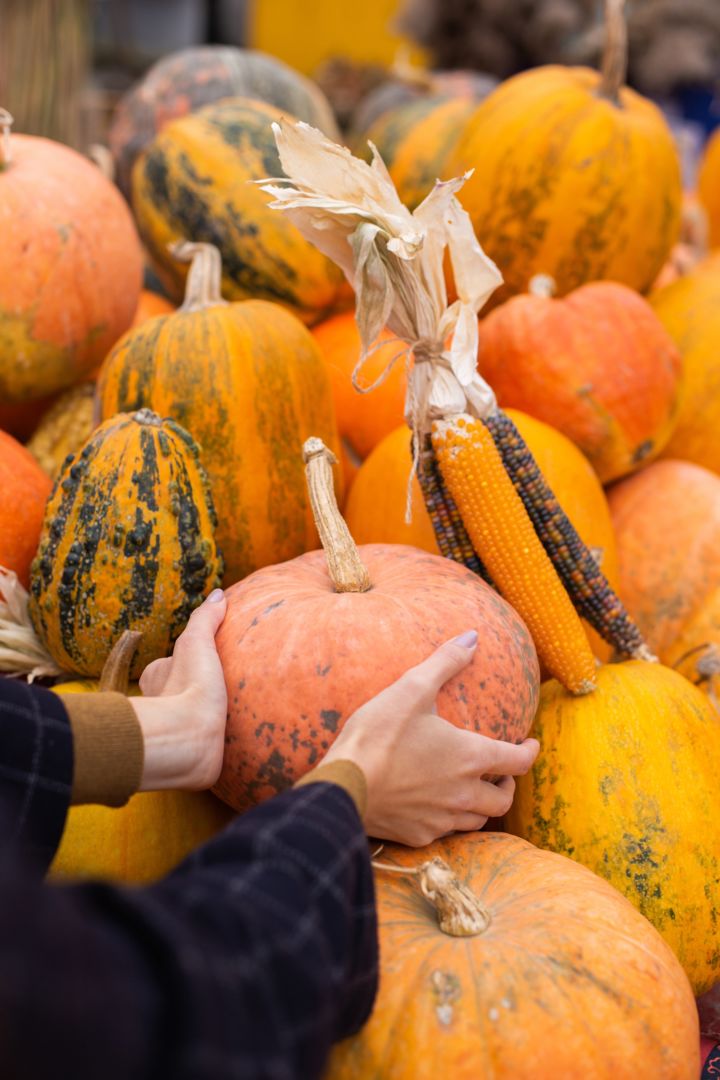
[{"x1": 63, "y1": 692, "x2": 145, "y2": 807}]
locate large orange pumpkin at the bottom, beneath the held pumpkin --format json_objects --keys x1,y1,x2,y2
[{"x1": 326, "y1": 833, "x2": 699, "y2": 1080}]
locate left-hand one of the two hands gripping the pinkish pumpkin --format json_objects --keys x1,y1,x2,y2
[{"x1": 130, "y1": 589, "x2": 228, "y2": 792}]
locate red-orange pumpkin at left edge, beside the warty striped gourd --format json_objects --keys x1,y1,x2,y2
[{"x1": 0, "y1": 431, "x2": 52, "y2": 588}]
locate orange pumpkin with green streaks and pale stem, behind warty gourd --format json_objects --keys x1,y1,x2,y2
[{"x1": 98, "y1": 241, "x2": 342, "y2": 584}]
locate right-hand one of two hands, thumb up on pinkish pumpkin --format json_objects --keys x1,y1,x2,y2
[{"x1": 324, "y1": 631, "x2": 540, "y2": 847}]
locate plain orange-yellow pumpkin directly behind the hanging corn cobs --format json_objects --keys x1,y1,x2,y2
[{"x1": 344, "y1": 409, "x2": 619, "y2": 660}]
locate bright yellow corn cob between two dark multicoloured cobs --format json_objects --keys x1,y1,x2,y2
[{"x1": 433, "y1": 416, "x2": 595, "y2": 693}]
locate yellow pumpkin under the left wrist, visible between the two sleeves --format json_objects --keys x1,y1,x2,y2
[{"x1": 50, "y1": 639, "x2": 233, "y2": 885}]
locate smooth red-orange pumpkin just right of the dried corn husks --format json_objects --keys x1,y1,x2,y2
[{"x1": 478, "y1": 282, "x2": 682, "y2": 483}]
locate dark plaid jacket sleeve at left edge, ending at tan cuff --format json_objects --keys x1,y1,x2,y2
[{"x1": 0, "y1": 677, "x2": 72, "y2": 869}]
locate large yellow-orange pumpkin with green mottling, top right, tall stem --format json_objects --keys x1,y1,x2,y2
[{"x1": 448, "y1": 66, "x2": 682, "y2": 299}]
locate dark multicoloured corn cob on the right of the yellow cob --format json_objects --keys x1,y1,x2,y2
[{"x1": 484, "y1": 409, "x2": 654, "y2": 659}]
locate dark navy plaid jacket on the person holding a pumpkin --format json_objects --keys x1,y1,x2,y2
[{"x1": 0, "y1": 678, "x2": 377, "y2": 1080}]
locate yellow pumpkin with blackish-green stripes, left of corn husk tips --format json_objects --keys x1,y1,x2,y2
[{"x1": 133, "y1": 97, "x2": 343, "y2": 323}]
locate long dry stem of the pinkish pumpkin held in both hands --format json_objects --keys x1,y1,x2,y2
[{"x1": 302, "y1": 437, "x2": 372, "y2": 593}]
